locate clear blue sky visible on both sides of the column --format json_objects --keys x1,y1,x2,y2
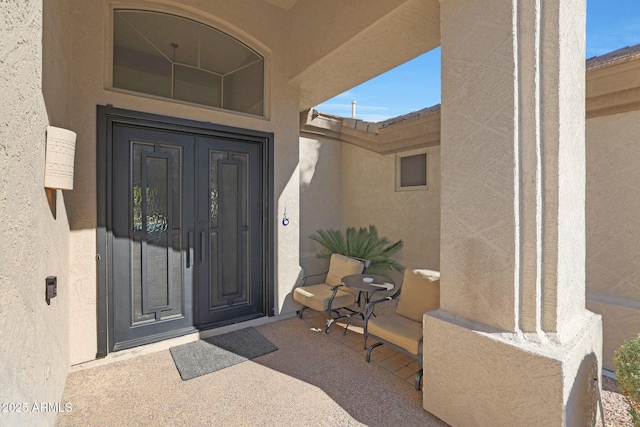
[{"x1": 315, "y1": 0, "x2": 640, "y2": 122}]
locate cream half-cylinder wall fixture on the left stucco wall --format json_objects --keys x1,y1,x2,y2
[{"x1": 44, "y1": 126, "x2": 76, "y2": 190}]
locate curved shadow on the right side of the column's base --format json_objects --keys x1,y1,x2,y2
[{"x1": 566, "y1": 353, "x2": 600, "y2": 426}]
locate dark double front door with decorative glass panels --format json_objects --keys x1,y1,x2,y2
[{"x1": 109, "y1": 124, "x2": 265, "y2": 350}]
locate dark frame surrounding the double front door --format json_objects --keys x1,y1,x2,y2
[{"x1": 96, "y1": 105, "x2": 275, "y2": 358}]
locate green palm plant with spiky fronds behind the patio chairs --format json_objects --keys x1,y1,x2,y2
[{"x1": 309, "y1": 225, "x2": 404, "y2": 276}]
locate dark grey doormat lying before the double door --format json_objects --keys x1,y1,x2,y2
[{"x1": 170, "y1": 327, "x2": 278, "y2": 381}]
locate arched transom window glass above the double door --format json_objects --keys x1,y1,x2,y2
[{"x1": 113, "y1": 10, "x2": 264, "y2": 115}]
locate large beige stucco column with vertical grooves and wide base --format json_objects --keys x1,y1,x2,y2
[{"x1": 423, "y1": 0, "x2": 602, "y2": 426}]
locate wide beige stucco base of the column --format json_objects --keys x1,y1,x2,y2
[{"x1": 423, "y1": 310, "x2": 602, "y2": 427}]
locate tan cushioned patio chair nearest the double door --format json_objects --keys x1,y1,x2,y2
[{"x1": 293, "y1": 254, "x2": 370, "y2": 333}]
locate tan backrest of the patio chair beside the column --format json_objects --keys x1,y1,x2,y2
[{"x1": 396, "y1": 269, "x2": 440, "y2": 322}]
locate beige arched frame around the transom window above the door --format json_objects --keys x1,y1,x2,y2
[{"x1": 103, "y1": 4, "x2": 272, "y2": 120}]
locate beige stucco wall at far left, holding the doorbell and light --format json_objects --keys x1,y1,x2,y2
[{"x1": 0, "y1": 1, "x2": 70, "y2": 426}]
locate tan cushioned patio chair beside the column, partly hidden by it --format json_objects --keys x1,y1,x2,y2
[{"x1": 364, "y1": 269, "x2": 440, "y2": 390}]
